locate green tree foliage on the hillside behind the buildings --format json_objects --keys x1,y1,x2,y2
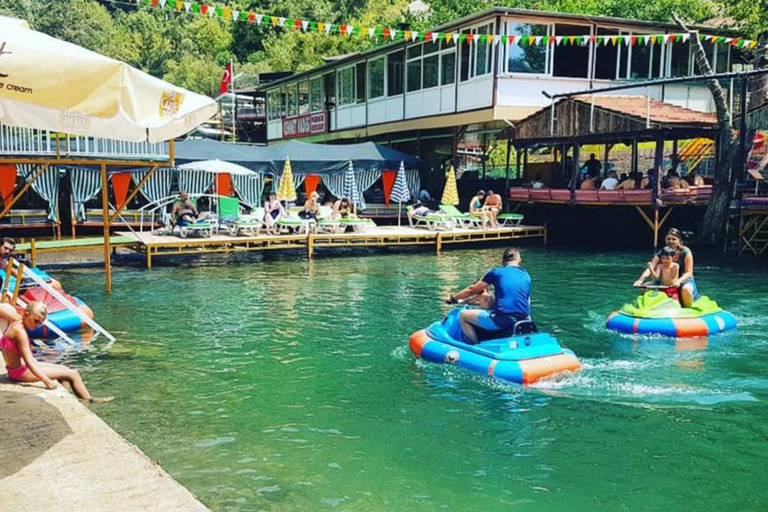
[{"x1": 0, "y1": 0, "x2": 768, "y2": 99}]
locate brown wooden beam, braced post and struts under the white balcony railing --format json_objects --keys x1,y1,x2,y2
[{"x1": 0, "y1": 140, "x2": 175, "y2": 292}]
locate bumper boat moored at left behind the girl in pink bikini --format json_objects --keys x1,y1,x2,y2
[{"x1": 9, "y1": 268, "x2": 93, "y2": 338}]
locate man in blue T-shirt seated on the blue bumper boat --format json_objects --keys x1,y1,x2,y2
[{"x1": 446, "y1": 248, "x2": 531, "y2": 345}]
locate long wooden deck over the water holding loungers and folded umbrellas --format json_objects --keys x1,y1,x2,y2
[{"x1": 118, "y1": 226, "x2": 547, "y2": 268}]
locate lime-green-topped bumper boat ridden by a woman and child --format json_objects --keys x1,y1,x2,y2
[{"x1": 605, "y1": 290, "x2": 736, "y2": 338}]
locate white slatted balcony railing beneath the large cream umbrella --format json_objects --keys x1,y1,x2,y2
[{"x1": 0, "y1": 124, "x2": 168, "y2": 160}]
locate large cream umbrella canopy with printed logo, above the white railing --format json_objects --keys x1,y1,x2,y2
[{"x1": 0, "y1": 16, "x2": 218, "y2": 142}]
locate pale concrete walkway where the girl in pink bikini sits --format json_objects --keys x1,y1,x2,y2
[{"x1": 0, "y1": 357, "x2": 208, "y2": 512}]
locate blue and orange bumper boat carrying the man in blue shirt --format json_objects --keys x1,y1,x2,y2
[{"x1": 410, "y1": 307, "x2": 581, "y2": 384}]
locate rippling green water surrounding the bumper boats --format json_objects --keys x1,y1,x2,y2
[{"x1": 59, "y1": 248, "x2": 768, "y2": 512}]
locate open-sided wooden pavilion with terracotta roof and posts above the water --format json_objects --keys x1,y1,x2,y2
[{"x1": 501, "y1": 94, "x2": 719, "y2": 247}]
